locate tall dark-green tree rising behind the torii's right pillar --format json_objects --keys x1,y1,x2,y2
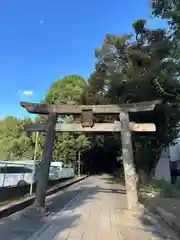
[{"x1": 82, "y1": 19, "x2": 180, "y2": 180}]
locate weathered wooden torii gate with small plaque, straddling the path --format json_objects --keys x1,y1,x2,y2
[{"x1": 20, "y1": 100, "x2": 161, "y2": 211}]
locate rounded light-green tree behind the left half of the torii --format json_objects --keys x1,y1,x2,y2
[{"x1": 45, "y1": 74, "x2": 91, "y2": 163}]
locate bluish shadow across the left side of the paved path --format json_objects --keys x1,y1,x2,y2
[{"x1": 0, "y1": 180, "x2": 98, "y2": 240}]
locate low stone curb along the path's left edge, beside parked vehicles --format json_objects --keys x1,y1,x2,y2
[{"x1": 0, "y1": 175, "x2": 88, "y2": 219}]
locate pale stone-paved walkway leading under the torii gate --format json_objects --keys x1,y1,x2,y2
[{"x1": 0, "y1": 175, "x2": 178, "y2": 240}]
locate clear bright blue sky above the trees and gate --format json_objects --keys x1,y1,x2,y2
[{"x1": 0, "y1": 0, "x2": 166, "y2": 118}]
